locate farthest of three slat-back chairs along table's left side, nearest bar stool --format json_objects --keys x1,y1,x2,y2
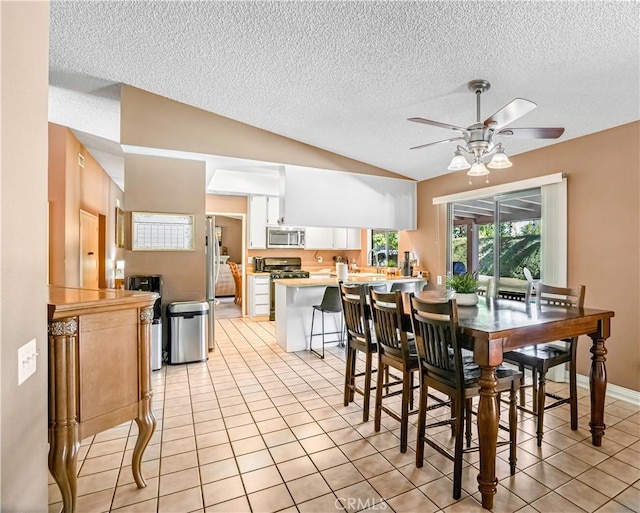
[{"x1": 339, "y1": 281, "x2": 386, "y2": 422}]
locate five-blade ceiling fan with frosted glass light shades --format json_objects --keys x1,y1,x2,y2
[{"x1": 409, "y1": 80, "x2": 564, "y2": 176}]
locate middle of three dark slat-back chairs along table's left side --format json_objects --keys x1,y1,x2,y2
[{"x1": 369, "y1": 290, "x2": 418, "y2": 452}]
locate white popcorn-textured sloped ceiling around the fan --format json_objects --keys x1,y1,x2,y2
[{"x1": 50, "y1": 0, "x2": 640, "y2": 179}]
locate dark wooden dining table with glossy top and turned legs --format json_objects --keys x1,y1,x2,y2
[{"x1": 403, "y1": 291, "x2": 614, "y2": 509}]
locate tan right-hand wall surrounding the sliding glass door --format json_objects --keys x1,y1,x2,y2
[{"x1": 406, "y1": 122, "x2": 640, "y2": 391}]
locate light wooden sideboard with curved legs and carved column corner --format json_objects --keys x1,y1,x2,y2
[{"x1": 48, "y1": 287, "x2": 158, "y2": 513}]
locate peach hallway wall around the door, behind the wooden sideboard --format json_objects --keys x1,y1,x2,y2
[{"x1": 49, "y1": 123, "x2": 124, "y2": 287}]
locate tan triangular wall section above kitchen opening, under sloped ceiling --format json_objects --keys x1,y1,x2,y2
[{"x1": 120, "y1": 85, "x2": 406, "y2": 182}]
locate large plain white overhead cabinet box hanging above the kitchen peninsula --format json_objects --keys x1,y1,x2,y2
[{"x1": 283, "y1": 166, "x2": 417, "y2": 230}]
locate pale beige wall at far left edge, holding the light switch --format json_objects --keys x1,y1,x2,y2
[{"x1": 0, "y1": 2, "x2": 49, "y2": 512}]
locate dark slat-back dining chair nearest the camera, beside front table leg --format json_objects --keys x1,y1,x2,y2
[{"x1": 410, "y1": 294, "x2": 520, "y2": 499}]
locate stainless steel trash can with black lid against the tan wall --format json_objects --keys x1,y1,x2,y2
[{"x1": 167, "y1": 301, "x2": 209, "y2": 364}]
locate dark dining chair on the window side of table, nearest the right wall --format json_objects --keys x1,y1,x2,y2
[{"x1": 503, "y1": 283, "x2": 585, "y2": 447}]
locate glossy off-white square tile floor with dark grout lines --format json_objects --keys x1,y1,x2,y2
[{"x1": 49, "y1": 319, "x2": 640, "y2": 513}]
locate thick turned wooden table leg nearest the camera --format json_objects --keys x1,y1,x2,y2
[{"x1": 478, "y1": 366, "x2": 498, "y2": 509}]
